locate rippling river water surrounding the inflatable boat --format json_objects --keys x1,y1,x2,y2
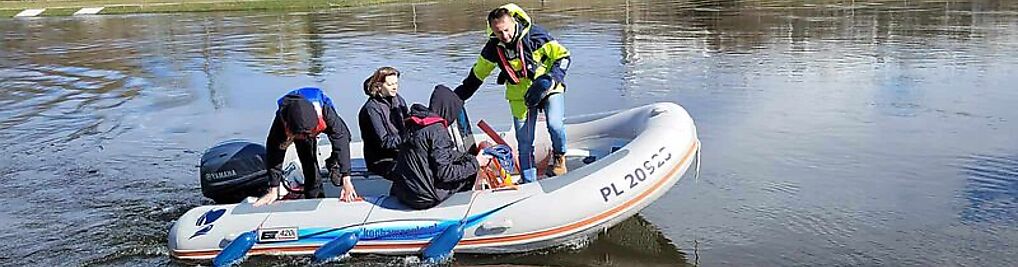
[{"x1": 0, "y1": 0, "x2": 1018, "y2": 266}]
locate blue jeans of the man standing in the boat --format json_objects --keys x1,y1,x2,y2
[{"x1": 513, "y1": 94, "x2": 566, "y2": 183}]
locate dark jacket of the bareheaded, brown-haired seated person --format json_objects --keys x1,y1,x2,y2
[{"x1": 357, "y1": 95, "x2": 409, "y2": 176}]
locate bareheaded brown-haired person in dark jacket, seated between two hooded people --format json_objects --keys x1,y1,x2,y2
[{"x1": 357, "y1": 66, "x2": 409, "y2": 177}]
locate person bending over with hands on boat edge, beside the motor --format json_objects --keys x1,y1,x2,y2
[{"x1": 253, "y1": 88, "x2": 357, "y2": 207}]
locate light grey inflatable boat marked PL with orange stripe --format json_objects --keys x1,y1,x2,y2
[{"x1": 168, "y1": 103, "x2": 699, "y2": 259}]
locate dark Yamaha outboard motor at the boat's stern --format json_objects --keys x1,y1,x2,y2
[{"x1": 201, "y1": 140, "x2": 269, "y2": 204}]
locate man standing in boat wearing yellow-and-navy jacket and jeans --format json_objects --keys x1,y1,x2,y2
[{"x1": 456, "y1": 4, "x2": 569, "y2": 182}]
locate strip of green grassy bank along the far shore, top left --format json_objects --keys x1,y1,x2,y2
[{"x1": 0, "y1": 0, "x2": 398, "y2": 17}]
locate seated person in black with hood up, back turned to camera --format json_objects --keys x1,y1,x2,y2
[{"x1": 389, "y1": 86, "x2": 486, "y2": 209}]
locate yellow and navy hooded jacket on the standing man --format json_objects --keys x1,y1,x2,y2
[{"x1": 456, "y1": 4, "x2": 570, "y2": 119}]
